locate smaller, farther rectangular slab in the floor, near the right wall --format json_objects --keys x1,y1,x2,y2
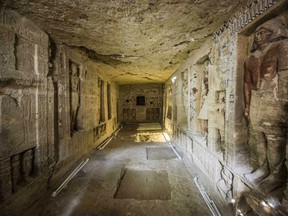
[{"x1": 146, "y1": 147, "x2": 177, "y2": 160}]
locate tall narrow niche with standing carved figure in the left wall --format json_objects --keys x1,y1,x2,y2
[{"x1": 69, "y1": 61, "x2": 80, "y2": 135}]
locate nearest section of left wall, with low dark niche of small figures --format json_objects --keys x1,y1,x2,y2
[{"x1": 0, "y1": 11, "x2": 50, "y2": 202}]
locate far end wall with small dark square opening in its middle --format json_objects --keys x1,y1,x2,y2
[{"x1": 119, "y1": 84, "x2": 163, "y2": 123}]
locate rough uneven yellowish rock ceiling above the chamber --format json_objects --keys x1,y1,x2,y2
[{"x1": 3, "y1": 0, "x2": 247, "y2": 84}]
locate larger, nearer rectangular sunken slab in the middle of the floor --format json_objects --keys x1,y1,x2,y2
[{"x1": 114, "y1": 169, "x2": 171, "y2": 200}]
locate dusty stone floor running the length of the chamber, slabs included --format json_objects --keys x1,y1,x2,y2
[{"x1": 23, "y1": 125, "x2": 211, "y2": 216}]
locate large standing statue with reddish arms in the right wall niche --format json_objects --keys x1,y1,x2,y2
[{"x1": 244, "y1": 19, "x2": 288, "y2": 192}]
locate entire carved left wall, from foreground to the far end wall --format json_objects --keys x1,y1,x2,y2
[{"x1": 0, "y1": 11, "x2": 119, "y2": 215}]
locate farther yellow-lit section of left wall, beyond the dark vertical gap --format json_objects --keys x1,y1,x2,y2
[{"x1": 51, "y1": 44, "x2": 118, "y2": 169}]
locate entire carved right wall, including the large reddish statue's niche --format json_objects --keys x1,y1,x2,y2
[{"x1": 164, "y1": 0, "x2": 288, "y2": 215}]
